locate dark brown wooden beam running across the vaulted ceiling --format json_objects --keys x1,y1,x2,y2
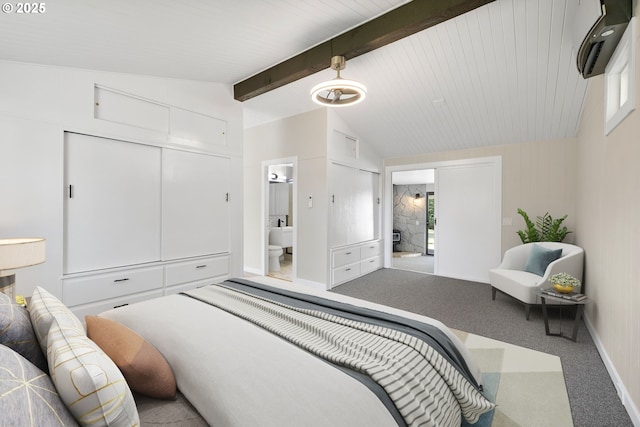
[{"x1": 233, "y1": 0, "x2": 494, "y2": 101}]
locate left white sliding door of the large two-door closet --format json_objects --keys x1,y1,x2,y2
[{"x1": 64, "y1": 133, "x2": 161, "y2": 273}]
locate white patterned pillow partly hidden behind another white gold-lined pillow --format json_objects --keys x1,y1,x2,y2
[{"x1": 27, "y1": 286, "x2": 84, "y2": 354}]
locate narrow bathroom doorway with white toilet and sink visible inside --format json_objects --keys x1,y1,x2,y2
[{"x1": 263, "y1": 158, "x2": 297, "y2": 281}]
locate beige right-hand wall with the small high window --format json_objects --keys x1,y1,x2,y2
[{"x1": 576, "y1": 2, "x2": 640, "y2": 425}]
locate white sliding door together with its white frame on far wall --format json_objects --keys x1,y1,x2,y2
[{"x1": 383, "y1": 156, "x2": 502, "y2": 283}]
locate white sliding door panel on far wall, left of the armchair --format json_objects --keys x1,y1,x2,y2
[{"x1": 435, "y1": 161, "x2": 502, "y2": 283}]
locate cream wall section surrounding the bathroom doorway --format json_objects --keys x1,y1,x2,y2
[{"x1": 243, "y1": 108, "x2": 327, "y2": 283}]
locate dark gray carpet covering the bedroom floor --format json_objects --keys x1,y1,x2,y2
[{"x1": 332, "y1": 269, "x2": 633, "y2": 427}]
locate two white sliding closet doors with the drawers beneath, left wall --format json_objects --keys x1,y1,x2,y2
[{"x1": 62, "y1": 133, "x2": 231, "y2": 318}]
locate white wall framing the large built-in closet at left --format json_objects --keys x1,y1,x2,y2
[{"x1": 0, "y1": 61, "x2": 243, "y2": 296}]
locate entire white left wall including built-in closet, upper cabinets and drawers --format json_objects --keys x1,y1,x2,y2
[{"x1": 0, "y1": 61, "x2": 243, "y2": 304}]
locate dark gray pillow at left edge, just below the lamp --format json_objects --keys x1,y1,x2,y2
[{"x1": 0, "y1": 293, "x2": 49, "y2": 372}]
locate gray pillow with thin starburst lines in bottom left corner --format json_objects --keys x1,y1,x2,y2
[{"x1": 0, "y1": 345, "x2": 78, "y2": 426}]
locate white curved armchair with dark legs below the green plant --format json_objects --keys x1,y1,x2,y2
[{"x1": 489, "y1": 242, "x2": 584, "y2": 320}]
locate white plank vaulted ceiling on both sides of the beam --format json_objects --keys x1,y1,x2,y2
[{"x1": 0, "y1": 0, "x2": 587, "y2": 157}]
